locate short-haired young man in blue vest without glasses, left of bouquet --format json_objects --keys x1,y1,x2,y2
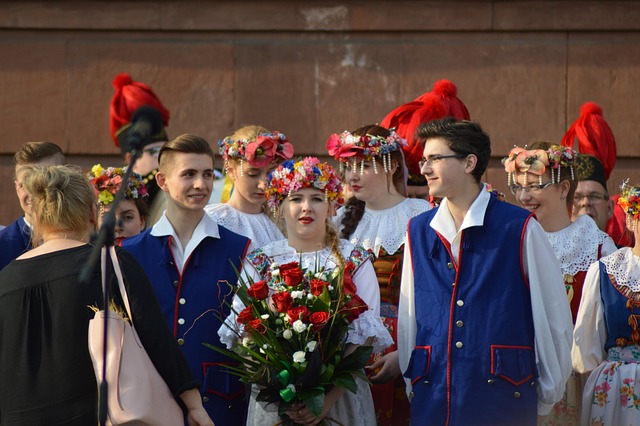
[{"x1": 122, "y1": 134, "x2": 249, "y2": 426}]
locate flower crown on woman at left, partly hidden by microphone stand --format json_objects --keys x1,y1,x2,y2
[{"x1": 88, "y1": 164, "x2": 149, "y2": 206}]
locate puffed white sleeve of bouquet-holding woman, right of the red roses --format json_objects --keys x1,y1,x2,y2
[{"x1": 347, "y1": 259, "x2": 393, "y2": 352}]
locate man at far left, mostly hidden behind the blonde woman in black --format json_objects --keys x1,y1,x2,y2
[{"x1": 0, "y1": 142, "x2": 65, "y2": 269}]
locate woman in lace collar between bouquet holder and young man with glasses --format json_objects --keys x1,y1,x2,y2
[{"x1": 327, "y1": 125, "x2": 431, "y2": 425}]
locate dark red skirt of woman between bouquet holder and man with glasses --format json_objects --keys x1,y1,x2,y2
[{"x1": 371, "y1": 303, "x2": 411, "y2": 426}]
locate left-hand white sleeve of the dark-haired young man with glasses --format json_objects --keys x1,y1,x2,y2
[{"x1": 397, "y1": 233, "x2": 418, "y2": 395}]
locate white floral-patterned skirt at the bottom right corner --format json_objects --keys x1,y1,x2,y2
[{"x1": 581, "y1": 346, "x2": 640, "y2": 426}]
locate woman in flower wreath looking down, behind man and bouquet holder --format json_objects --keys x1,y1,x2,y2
[{"x1": 205, "y1": 125, "x2": 293, "y2": 250}]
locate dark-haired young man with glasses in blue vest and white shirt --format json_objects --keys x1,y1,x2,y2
[{"x1": 398, "y1": 118, "x2": 572, "y2": 426}]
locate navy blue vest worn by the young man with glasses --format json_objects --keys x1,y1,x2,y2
[{"x1": 405, "y1": 197, "x2": 538, "y2": 426}]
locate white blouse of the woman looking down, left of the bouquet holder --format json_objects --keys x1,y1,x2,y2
[{"x1": 204, "y1": 203, "x2": 284, "y2": 252}]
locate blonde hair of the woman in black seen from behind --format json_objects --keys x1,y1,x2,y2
[{"x1": 23, "y1": 166, "x2": 96, "y2": 247}]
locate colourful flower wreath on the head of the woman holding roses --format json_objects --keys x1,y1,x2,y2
[{"x1": 265, "y1": 157, "x2": 343, "y2": 212}]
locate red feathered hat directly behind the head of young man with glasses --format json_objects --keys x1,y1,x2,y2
[{"x1": 380, "y1": 80, "x2": 469, "y2": 180}]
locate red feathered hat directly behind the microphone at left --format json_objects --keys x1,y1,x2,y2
[{"x1": 109, "y1": 72, "x2": 169, "y2": 148}]
